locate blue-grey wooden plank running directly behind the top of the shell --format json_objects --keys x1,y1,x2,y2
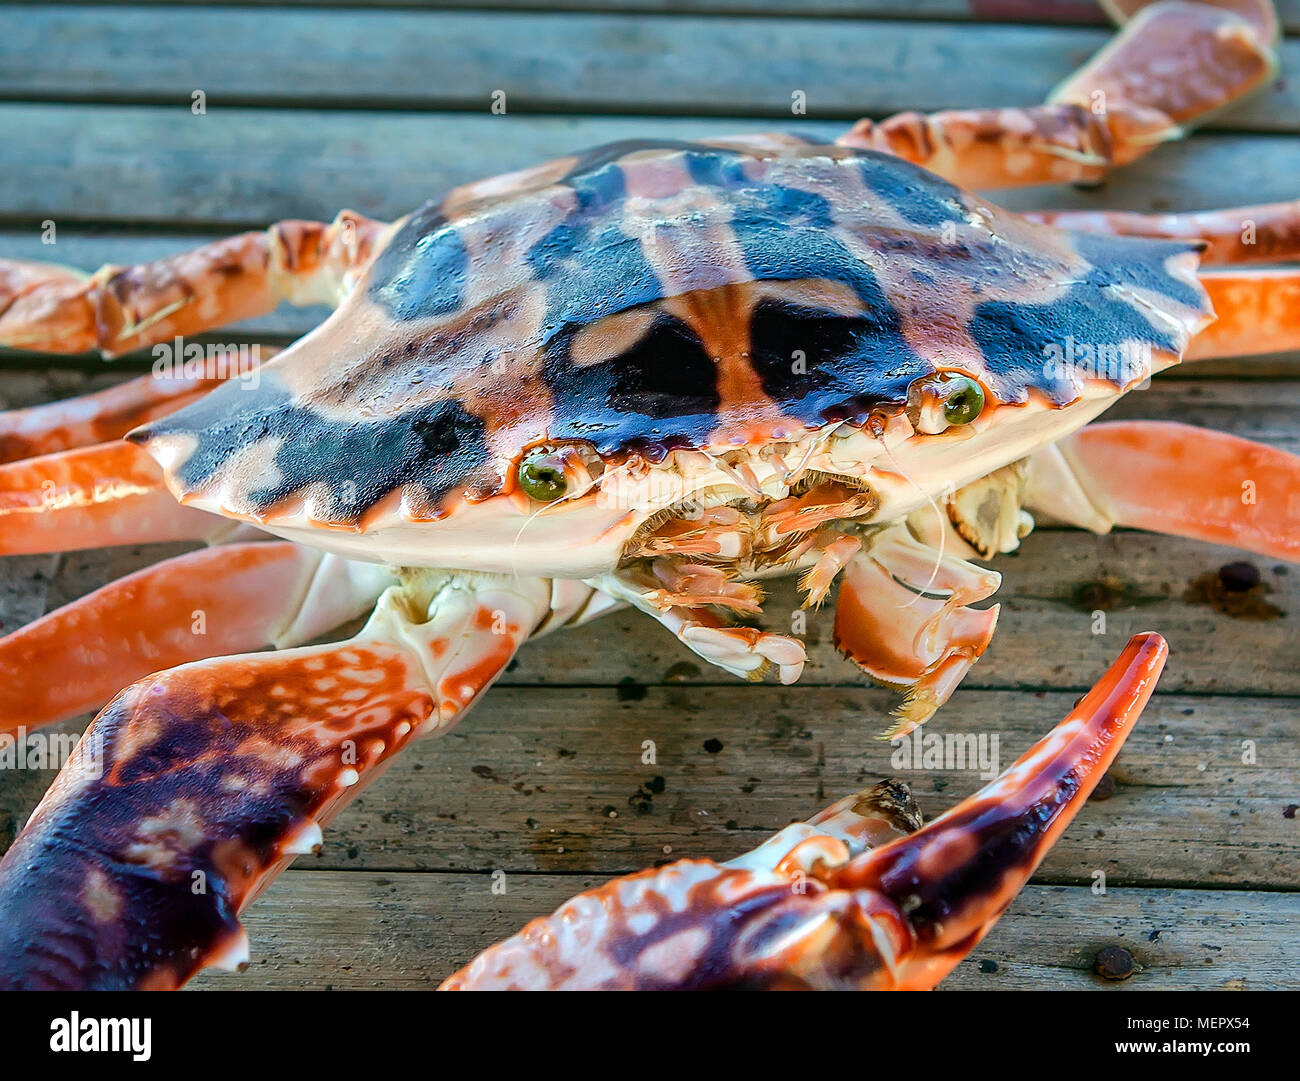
[{"x1": 0, "y1": 104, "x2": 1300, "y2": 229}]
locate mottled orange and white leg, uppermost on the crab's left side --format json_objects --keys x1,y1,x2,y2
[{"x1": 0, "y1": 210, "x2": 387, "y2": 356}]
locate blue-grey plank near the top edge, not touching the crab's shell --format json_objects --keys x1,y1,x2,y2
[{"x1": 0, "y1": 6, "x2": 1300, "y2": 131}]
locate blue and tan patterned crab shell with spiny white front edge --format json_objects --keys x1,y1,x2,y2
[{"x1": 131, "y1": 136, "x2": 1212, "y2": 577}]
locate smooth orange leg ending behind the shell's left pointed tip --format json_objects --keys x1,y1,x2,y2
[{"x1": 0, "y1": 443, "x2": 230, "y2": 556}]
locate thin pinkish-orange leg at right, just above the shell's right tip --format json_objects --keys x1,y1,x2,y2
[{"x1": 1021, "y1": 199, "x2": 1300, "y2": 266}]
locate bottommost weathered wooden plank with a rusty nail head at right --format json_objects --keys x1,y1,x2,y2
[{"x1": 194, "y1": 872, "x2": 1300, "y2": 990}]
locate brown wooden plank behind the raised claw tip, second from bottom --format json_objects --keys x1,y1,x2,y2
[{"x1": 0, "y1": 665, "x2": 1300, "y2": 889}]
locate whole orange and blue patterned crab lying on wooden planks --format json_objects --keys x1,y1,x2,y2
[{"x1": 0, "y1": 0, "x2": 1300, "y2": 987}]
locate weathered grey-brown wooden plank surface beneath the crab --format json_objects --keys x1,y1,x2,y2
[{"x1": 0, "y1": 0, "x2": 1300, "y2": 989}]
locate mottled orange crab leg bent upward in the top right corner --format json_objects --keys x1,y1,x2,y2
[{"x1": 836, "y1": 0, "x2": 1277, "y2": 188}]
